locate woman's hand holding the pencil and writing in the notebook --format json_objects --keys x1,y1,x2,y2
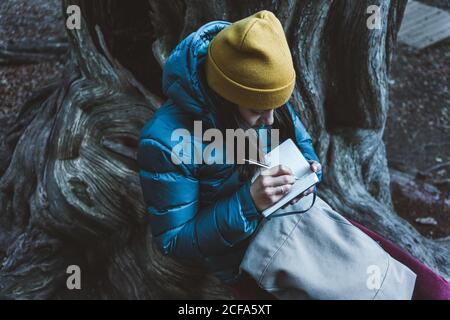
[{"x1": 250, "y1": 166, "x2": 295, "y2": 211}]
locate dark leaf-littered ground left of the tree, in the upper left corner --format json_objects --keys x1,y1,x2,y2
[{"x1": 0, "y1": 0, "x2": 66, "y2": 128}]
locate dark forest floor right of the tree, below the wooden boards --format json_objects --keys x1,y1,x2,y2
[{"x1": 384, "y1": 0, "x2": 450, "y2": 238}]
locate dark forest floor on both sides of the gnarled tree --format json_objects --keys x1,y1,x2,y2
[{"x1": 0, "y1": 0, "x2": 450, "y2": 237}]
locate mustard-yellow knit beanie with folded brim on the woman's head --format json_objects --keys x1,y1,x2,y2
[{"x1": 206, "y1": 10, "x2": 295, "y2": 110}]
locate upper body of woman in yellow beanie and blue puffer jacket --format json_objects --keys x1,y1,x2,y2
[{"x1": 139, "y1": 11, "x2": 448, "y2": 300}]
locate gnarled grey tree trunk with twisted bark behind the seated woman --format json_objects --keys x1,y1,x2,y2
[{"x1": 0, "y1": 0, "x2": 450, "y2": 299}]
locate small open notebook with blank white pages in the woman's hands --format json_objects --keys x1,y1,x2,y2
[{"x1": 262, "y1": 139, "x2": 319, "y2": 217}]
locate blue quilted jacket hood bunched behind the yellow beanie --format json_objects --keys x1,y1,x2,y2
[{"x1": 162, "y1": 21, "x2": 231, "y2": 122}]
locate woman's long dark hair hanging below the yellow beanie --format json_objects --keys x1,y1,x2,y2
[{"x1": 208, "y1": 89, "x2": 295, "y2": 181}]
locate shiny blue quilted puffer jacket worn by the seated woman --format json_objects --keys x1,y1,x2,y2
[{"x1": 138, "y1": 21, "x2": 319, "y2": 283}]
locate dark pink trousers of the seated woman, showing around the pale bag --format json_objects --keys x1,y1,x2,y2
[{"x1": 231, "y1": 219, "x2": 450, "y2": 300}]
